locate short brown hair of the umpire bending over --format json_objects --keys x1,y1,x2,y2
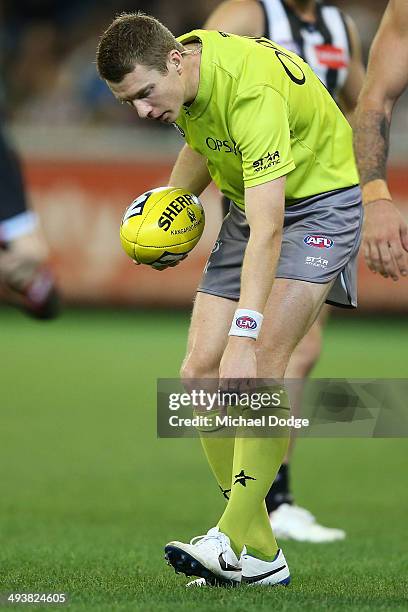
[{"x1": 96, "y1": 11, "x2": 184, "y2": 83}]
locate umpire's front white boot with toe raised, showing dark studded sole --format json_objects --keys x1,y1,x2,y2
[{"x1": 164, "y1": 527, "x2": 241, "y2": 586}]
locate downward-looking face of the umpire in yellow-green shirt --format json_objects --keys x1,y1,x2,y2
[{"x1": 108, "y1": 61, "x2": 184, "y2": 123}]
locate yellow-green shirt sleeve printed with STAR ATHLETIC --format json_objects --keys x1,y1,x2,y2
[{"x1": 230, "y1": 85, "x2": 296, "y2": 187}]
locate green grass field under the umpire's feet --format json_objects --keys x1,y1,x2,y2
[{"x1": 0, "y1": 309, "x2": 408, "y2": 612}]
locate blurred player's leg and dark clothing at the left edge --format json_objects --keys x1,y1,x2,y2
[{"x1": 0, "y1": 124, "x2": 59, "y2": 320}]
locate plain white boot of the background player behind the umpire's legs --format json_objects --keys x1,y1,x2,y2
[{"x1": 269, "y1": 504, "x2": 346, "y2": 543}]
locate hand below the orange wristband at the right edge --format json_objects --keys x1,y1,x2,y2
[{"x1": 363, "y1": 200, "x2": 408, "y2": 281}]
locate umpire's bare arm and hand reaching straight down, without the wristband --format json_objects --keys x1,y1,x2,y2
[{"x1": 220, "y1": 176, "x2": 286, "y2": 380}]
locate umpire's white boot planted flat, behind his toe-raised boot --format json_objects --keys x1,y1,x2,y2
[{"x1": 186, "y1": 549, "x2": 290, "y2": 587}]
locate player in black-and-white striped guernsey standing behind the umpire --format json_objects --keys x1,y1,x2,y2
[{"x1": 202, "y1": 0, "x2": 364, "y2": 542}]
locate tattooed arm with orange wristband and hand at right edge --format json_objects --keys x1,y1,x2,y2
[{"x1": 354, "y1": 0, "x2": 408, "y2": 280}]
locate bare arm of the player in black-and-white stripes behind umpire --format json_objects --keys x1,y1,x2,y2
[{"x1": 339, "y1": 15, "x2": 365, "y2": 123}]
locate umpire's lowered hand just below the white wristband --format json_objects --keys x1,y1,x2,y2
[{"x1": 219, "y1": 336, "x2": 256, "y2": 391}]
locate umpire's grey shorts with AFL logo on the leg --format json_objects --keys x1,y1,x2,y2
[{"x1": 198, "y1": 186, "x2": 363, "y2": 308}]
